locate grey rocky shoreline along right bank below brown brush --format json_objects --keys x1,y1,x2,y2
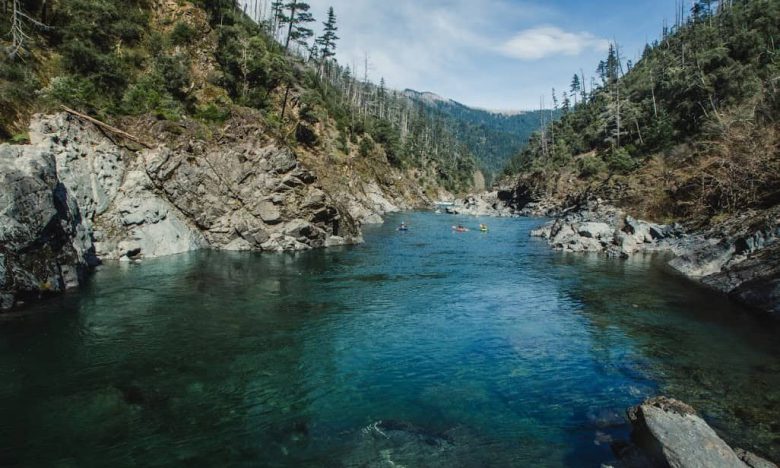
[{"x1": 515, "y1": 199, "x2": 780, "y2": 318}]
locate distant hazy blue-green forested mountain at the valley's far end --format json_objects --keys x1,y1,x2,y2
[{"x1": 404, "y1": 89, "x2": 557, "y2": 182}]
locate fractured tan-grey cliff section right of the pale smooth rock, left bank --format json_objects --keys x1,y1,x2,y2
[{"x1": 145, "y1": 142, "x2": 359, "y2": 251}]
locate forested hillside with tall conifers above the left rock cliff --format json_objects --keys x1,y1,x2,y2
[{"x1": 0, "y1": 0, "x2": 476, "y2": 191}]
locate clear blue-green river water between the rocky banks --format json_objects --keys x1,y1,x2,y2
[{"x1": 0, "y1": 214, "x2": 780, "y2": 466}]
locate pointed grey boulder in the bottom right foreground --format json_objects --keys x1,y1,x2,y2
[{"x1": 615, "y1": 397, "x2": 775, "y2": 468}]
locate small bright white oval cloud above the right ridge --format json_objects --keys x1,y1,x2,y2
[{"x1": 499, "y1": 26, "x2": 609, "y2": 60}]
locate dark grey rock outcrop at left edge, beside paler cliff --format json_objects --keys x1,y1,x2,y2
[{"x1": 0, "y1": 145, "x2": 95, "y2": 309}]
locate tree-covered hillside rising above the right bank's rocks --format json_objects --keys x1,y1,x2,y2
[{"x1": 509, "y1": 0, "x2": 780, "y2": 222}]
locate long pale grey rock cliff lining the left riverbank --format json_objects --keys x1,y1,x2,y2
[{"x1": 0, "y1": 113, "x2": 428, "y2": 309}]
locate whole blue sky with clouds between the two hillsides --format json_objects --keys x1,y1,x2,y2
[{"x1": 244, "y1": 0, "x2": 676, "y2": 111}]
